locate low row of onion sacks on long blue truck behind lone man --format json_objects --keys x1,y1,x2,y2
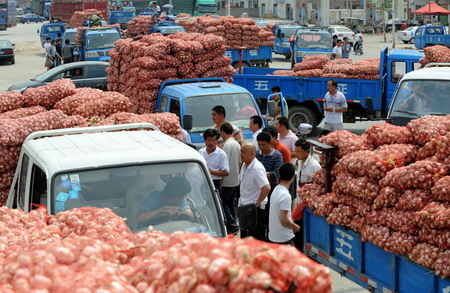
[{"x1": 272, "y1": 55, "x2": 380, "y2": 80}]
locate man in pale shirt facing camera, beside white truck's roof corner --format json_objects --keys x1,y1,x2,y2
[{"x1": 199, "y1": 129, "x2": 230, "y2": 194}]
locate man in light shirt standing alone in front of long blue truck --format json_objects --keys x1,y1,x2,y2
[{"x1": 323, "y1": 79, "x2": 347, "y2": 131}]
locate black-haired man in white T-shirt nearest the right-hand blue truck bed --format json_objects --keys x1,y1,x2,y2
[{"x1": 269, "y1": 163, "x2": 300, "y2": 245}]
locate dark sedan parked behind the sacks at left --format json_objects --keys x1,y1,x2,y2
[{"x1": 8, "y1": 61, "x2": 109, "y2": 92}]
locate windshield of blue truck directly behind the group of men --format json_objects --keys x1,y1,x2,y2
[{"x1": 186, "y1": 93, "x2": 258, "y2": 132}]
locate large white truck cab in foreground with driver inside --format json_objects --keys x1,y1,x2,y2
[{"x1": 6, "y1": 123, "x2": 226, "y2": 237}]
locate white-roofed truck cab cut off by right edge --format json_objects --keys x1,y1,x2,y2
[{"x1": 387, "y1": 64, "x2": 450, "y2": 126}]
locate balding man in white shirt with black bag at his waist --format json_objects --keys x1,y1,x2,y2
[{"x1": 238, "y1": 143, "x2": 270, "y2": 241}]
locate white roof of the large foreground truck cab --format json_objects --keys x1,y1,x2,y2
[{"x1": 23, "y1": 125, "x2": 204, "y2": 174}]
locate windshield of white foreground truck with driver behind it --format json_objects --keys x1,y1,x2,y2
[{"x1": 52, "y1": 162, "x2": 224, "y2": 237}]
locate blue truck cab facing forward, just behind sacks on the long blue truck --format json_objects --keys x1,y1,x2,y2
[{"x1": 290, "y1": 27, "x2": 333, "y2": 68}]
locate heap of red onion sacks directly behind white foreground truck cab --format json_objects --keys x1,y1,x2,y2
[{"x1": 0, "y1": 79, "x2": 182, "y2": 205}]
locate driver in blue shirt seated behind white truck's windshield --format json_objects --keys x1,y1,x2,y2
[{"x1": 136, "y1": 176, "x2": 194, "y2": 226}]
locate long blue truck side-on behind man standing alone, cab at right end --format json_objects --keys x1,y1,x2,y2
[{"x1": 233, "y1": 47, "x2": 424, "y2": 129}]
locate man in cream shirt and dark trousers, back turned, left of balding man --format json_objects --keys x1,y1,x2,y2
[{"x1": 220, "y1": 123, "x2": 241, "y2": 234}]
